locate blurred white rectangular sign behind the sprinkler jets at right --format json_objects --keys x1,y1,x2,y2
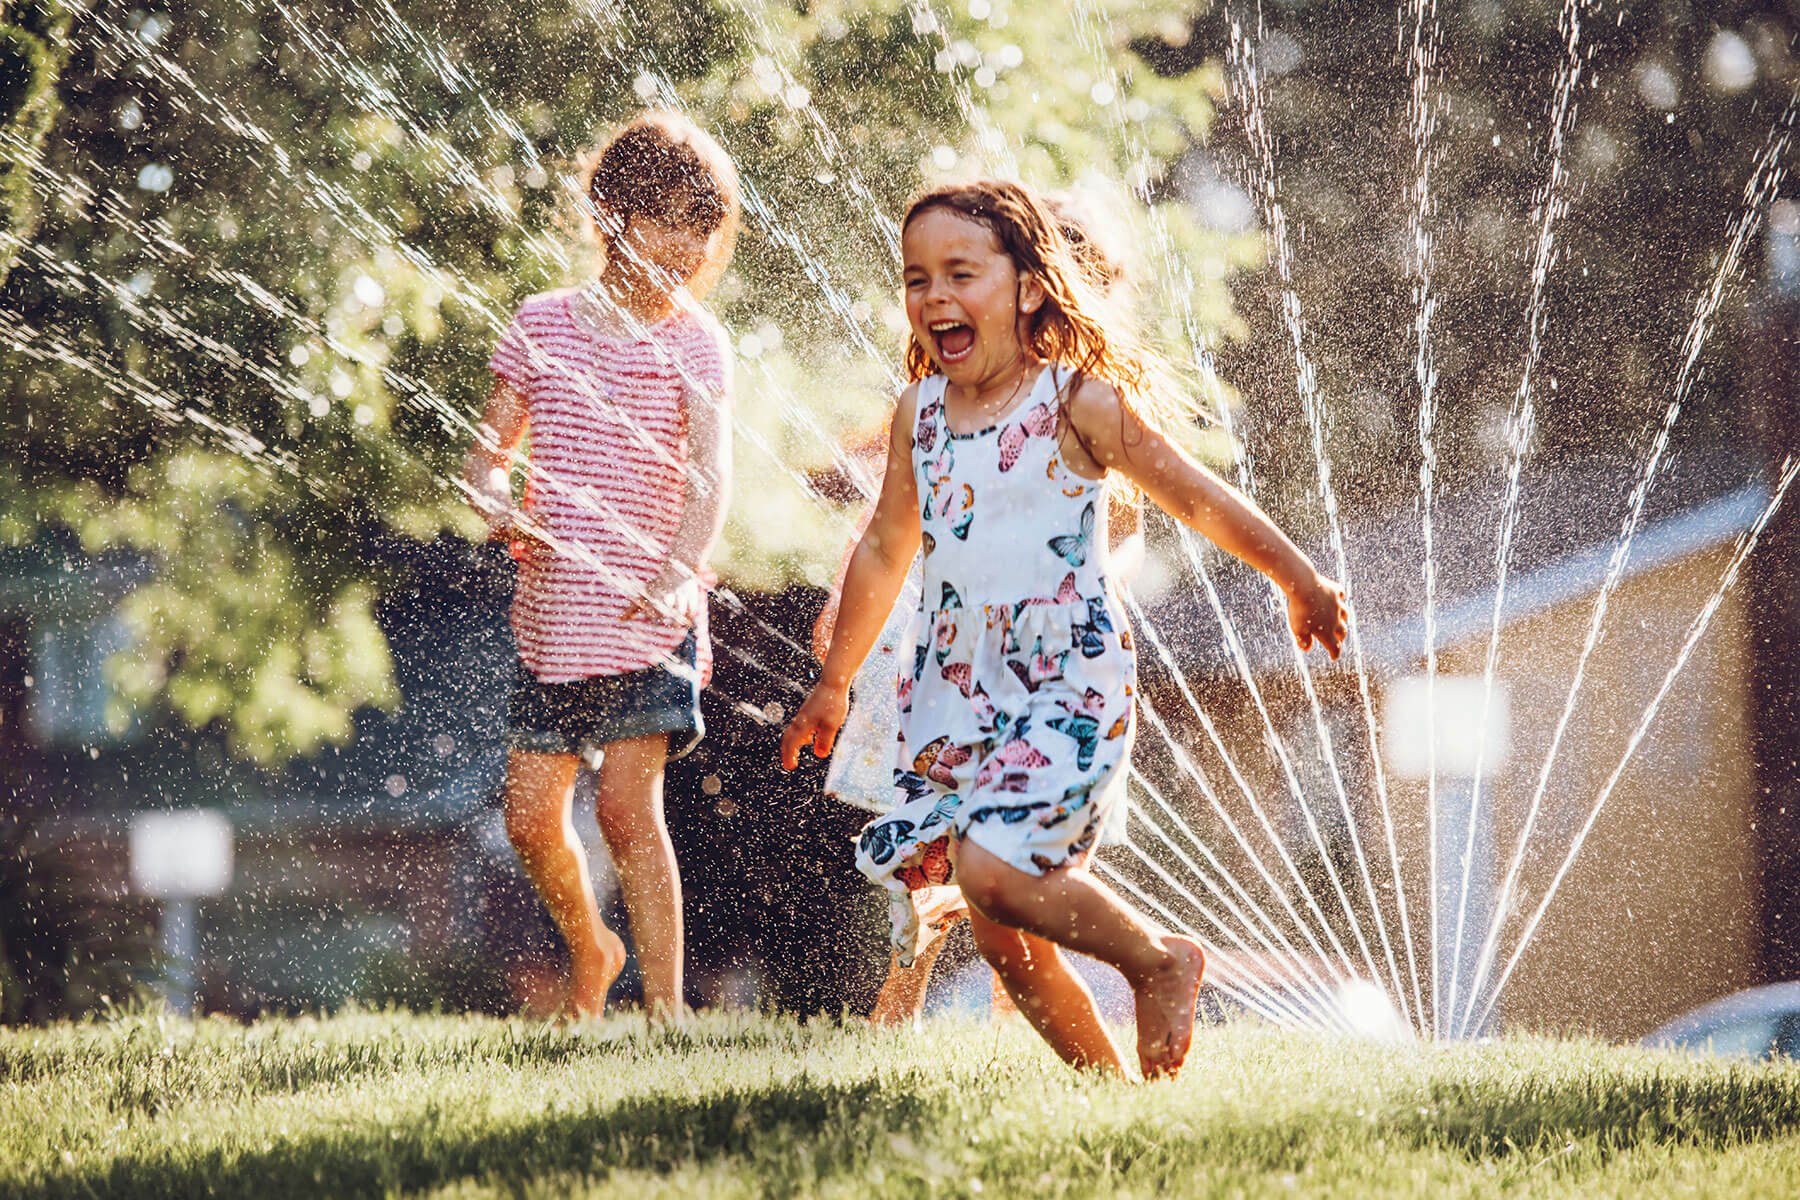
[{"x1": 1381, "y1": 675, "x2": 1512, "y2": 779}]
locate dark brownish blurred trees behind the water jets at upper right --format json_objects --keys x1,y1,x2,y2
[{"x1": 1134, "y1": 0, "x2": 1800, "y2": 518}]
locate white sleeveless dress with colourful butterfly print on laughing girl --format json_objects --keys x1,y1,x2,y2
[{"x1": 857, "y1": 367, "x2": 1136, "y2": 964}]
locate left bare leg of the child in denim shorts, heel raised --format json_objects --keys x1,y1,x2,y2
[{"x1": 506, "y1": 750, "x2": 625, "y2": 1016}]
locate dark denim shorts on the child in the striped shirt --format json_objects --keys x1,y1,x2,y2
[{"x1": 506, "y1": 631, "x2": 706, "y2": 759}]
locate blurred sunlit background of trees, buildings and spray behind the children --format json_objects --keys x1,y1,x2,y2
[{"x1": 0, "y1": 0, "x2": 1800, "y2": 1036}]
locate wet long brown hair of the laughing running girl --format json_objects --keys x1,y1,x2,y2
[{"x1": 900, "y1": 180, "x2": 1206, "y2": 440}]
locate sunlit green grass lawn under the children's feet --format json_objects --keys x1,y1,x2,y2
[{"x1": 0, "y1": 1015, "x2": 1800, "y2": 1200}]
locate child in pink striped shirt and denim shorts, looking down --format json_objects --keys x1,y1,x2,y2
[{"x1": 464, "y1": 113, "x2": 738, "y2": 1015}]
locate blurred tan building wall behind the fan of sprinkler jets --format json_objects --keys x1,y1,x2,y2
[{"x1": 1137, "y1": 542, "x2": 1766, "y2": 1038}]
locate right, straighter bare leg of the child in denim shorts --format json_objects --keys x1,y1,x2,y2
[{"x1": 594, "y1": 734, "x2": 682, "y2": 1016}]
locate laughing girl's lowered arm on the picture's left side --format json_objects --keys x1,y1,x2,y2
[{"x1": 781, "y1": 385, "x2": 920, "y2": 770}]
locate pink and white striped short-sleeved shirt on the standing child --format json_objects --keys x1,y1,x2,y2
[{"x1": 488, "y1": 290, "x2": 731, "y2": 684}]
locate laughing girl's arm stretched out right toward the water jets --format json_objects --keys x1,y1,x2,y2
[{"x1": 1062, "y1": 380, "x2": 1350, "y2": 658}]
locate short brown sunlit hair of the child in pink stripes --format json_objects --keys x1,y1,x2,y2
[{"x1": 578, "y1": 112, "x2": 742, "y2": 299}]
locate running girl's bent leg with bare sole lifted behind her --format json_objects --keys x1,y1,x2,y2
[{"x1": 956, "y1": 838, "x2": 1206, "y2": 1079}]
